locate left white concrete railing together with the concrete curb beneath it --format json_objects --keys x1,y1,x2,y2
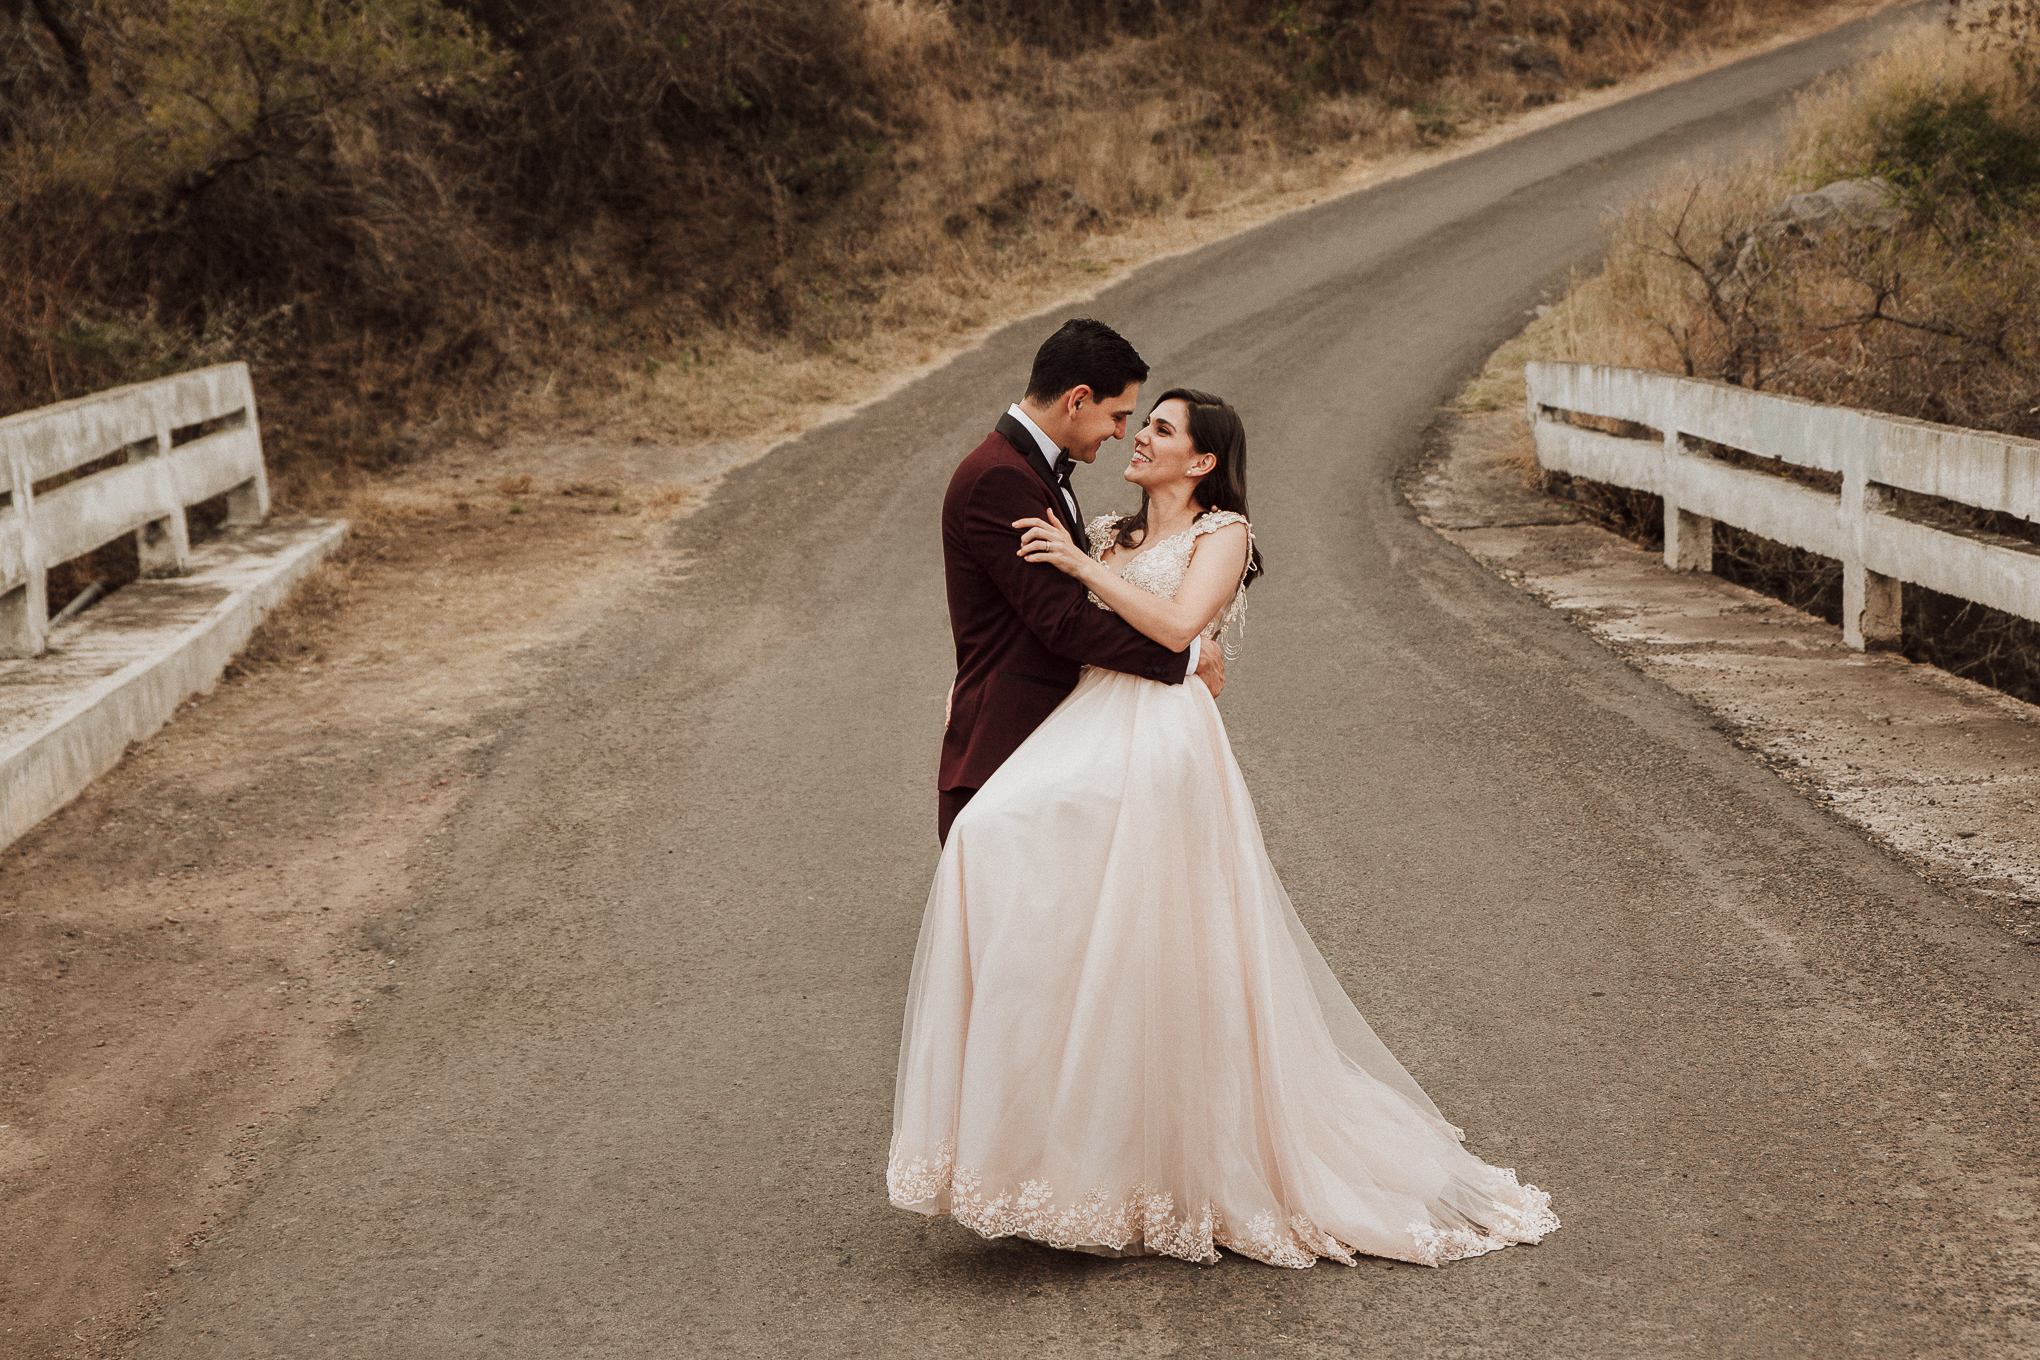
[{"x1": 0, "y1": 363, "x2": 347, "y2": 846}]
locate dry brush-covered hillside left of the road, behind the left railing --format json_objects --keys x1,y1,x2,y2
[{"x1": 0, "y1": 0, "x2": 1868, "y2": 510}]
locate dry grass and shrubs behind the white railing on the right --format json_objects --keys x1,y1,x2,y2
[{"x1": 1536, "y1": 14, "x2": 2040, "y2": 701}]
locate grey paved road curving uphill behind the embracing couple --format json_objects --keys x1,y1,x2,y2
[{"x1": 143, "y1": 13, "x2": 2040, "y2": 1360}]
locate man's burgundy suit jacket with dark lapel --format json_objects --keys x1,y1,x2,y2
[{"x1": 936, "y1": 414, "x2": 1189, "y2": 789}]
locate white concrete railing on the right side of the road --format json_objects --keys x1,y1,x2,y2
[{"x1": 1526, "y1": 363, "x2": 2040, "y2": 650}]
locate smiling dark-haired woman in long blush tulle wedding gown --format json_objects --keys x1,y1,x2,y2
[{"x1": 885, "y1": 389, "x2": 1559, "y2": 1266}]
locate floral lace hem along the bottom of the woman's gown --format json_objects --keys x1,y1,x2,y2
[{"x1": 885, "y1": 1138, "x2": 1559, "y2": 1270}]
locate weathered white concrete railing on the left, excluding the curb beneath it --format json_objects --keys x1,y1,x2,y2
[{"x1": 0, "y1": 363, "x2": 269, "y2": 657}]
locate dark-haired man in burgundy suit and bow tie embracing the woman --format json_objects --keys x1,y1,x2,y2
[{"x1": 936, "y1": 320, "x2": 1226, "y2": 842}]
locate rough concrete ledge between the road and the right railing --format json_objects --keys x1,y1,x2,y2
[{"x1": 1397, "y1": 340, "x2": 2040, "y2": 948}]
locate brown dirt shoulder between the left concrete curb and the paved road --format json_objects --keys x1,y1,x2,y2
[{"x1": 0, "y1": 467, "x2": 690, "y2": 1356}]
